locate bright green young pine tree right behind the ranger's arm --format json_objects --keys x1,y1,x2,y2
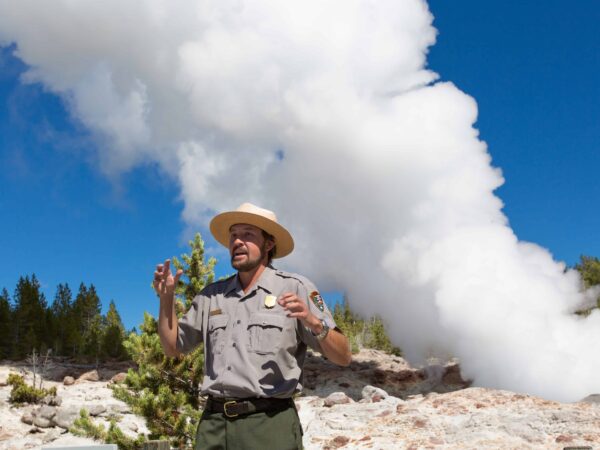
[{"x1": 113, "y1": 234, "x2": 215, "y2": 448}]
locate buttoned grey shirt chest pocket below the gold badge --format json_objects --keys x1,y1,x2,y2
[{"x1": 248, "y1": 313, "x2": 286, "y2": 355}]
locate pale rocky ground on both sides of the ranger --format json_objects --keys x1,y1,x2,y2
[{"x1": 0, "y1": 350, "x2": 600, "y2": 450}]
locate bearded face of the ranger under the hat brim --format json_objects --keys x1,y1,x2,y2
[{"x1": 229, "y1": 223, "x2": 272, "y2": 272}]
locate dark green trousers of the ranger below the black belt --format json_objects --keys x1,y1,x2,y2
[{"x1": 195, "y1": 406, "x2": 302, "y2": 450}]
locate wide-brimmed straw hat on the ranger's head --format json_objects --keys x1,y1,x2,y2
[{"x1": 210, "y1": 203, "x2": 294, "y2": 258}]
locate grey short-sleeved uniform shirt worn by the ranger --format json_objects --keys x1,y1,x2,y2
[{"x1": 177, "y1": 267, "x2": 335, "y2": 398}]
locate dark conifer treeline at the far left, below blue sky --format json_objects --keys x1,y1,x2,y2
[{"x1": 0, "y1": 274, "x2": 127, "y2": 362}]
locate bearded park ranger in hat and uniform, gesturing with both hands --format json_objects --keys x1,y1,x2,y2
[{"x1": 154, "y1": 203, "x2": 351, "y2": 450}]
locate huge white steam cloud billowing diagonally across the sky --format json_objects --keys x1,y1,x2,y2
[{"x1": 0, "y1": 0, "x2": 600, "y2": 400}]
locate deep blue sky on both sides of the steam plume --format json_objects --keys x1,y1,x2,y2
[{"x1": 0, "y1": 0, "x2": 600, "y2": 328}]
